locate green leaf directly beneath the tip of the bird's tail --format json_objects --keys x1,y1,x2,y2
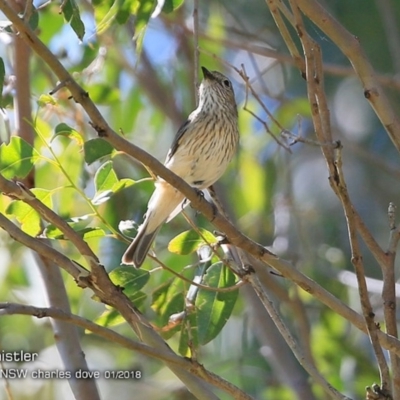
[{"x1": 109, "y1": 267, "x2": 150, "y2": 298}]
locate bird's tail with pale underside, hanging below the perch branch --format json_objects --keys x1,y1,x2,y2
[{"x1": 122, "y1": 181, "x2": 184, "y2": 268}]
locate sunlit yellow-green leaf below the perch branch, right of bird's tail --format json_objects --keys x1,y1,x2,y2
[{"x1": 168, "y1": 228, "x2": 217, "y2": 255}]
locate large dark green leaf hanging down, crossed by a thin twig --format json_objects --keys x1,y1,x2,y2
[{"x1": 195, "y1": 262, "x2": 239, "y2": 345}]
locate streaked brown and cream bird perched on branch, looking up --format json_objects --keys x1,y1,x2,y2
[{"x1": 121, "y1": 67, "x2": 239, "y2": 268}]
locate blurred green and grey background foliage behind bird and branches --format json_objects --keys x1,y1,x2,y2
[{"x1": 0, "y1": 0, "x2": 400, "y2": 400}]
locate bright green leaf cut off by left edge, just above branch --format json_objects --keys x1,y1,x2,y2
[{"x1": 0, "y1": 136, "x2": 40, "y2": 179}]
